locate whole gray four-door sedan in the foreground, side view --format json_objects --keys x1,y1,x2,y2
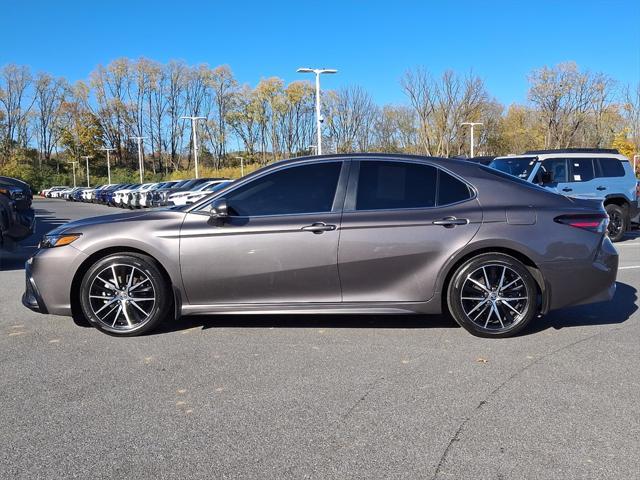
[{"x1": 23, "y1": 154, "x2": 618, "y2": 337}]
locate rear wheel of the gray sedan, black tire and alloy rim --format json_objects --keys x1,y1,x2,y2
[{"x1": 447, "y1": 253, "x2": 539, "y2": 338}]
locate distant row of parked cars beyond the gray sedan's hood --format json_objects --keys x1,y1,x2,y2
[{"x1": 40, "y1": 178, "x2": 231, "y2": 209}]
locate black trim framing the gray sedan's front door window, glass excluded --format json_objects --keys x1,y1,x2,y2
[{"x1": 186, "y1": 158, "x2": 353, "y2": 218}]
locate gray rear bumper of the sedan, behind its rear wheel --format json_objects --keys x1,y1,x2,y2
[{"x1": 540, "y1": 237, "x2": 618, "y2": 313}]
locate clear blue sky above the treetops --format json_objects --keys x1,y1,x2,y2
[{"x1": 0, "y1": 0, "x2": 640, "y2": 104}]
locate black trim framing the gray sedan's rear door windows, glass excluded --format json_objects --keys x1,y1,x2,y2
[{"x1": 344, "y1": 156, "x2": 478, "y2": 213}]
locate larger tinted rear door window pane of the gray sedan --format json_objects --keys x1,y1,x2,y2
[{"x1": 356, "y1": 161, "x2": 438, "y2": 210}]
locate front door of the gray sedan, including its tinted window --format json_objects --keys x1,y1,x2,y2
[{"x1": 180, "y1": 160, "x2": 349, "y2": 305}]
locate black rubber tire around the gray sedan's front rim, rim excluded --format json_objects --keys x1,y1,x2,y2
[{"x1": 79, "y1": 253, "x2": 170, "y2": 337}]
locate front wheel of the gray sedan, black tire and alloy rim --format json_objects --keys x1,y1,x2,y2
[{"x1": 79, "y1": 253, "x2": 173, "y2": 337}]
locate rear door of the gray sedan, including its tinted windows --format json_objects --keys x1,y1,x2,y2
[{"x1": 338, "y1": 159, "x2": 482, "y2": 302}]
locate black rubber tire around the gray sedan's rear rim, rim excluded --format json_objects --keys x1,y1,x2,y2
[{"x1": 447, "y1": 253, "x2": 538, "y2": 338}]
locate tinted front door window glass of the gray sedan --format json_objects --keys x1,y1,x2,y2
[{"x1": 225, "y1": 162, "x2": 342, "y2": 217}]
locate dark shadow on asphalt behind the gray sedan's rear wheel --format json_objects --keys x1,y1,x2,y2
[{"x1": 522, "y1": 282, "x2": 638, "y2": 335}]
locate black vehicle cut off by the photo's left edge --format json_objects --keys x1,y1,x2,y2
[{"x1": 0, "y1": 176, "x2": 35, "y2": 246}]
